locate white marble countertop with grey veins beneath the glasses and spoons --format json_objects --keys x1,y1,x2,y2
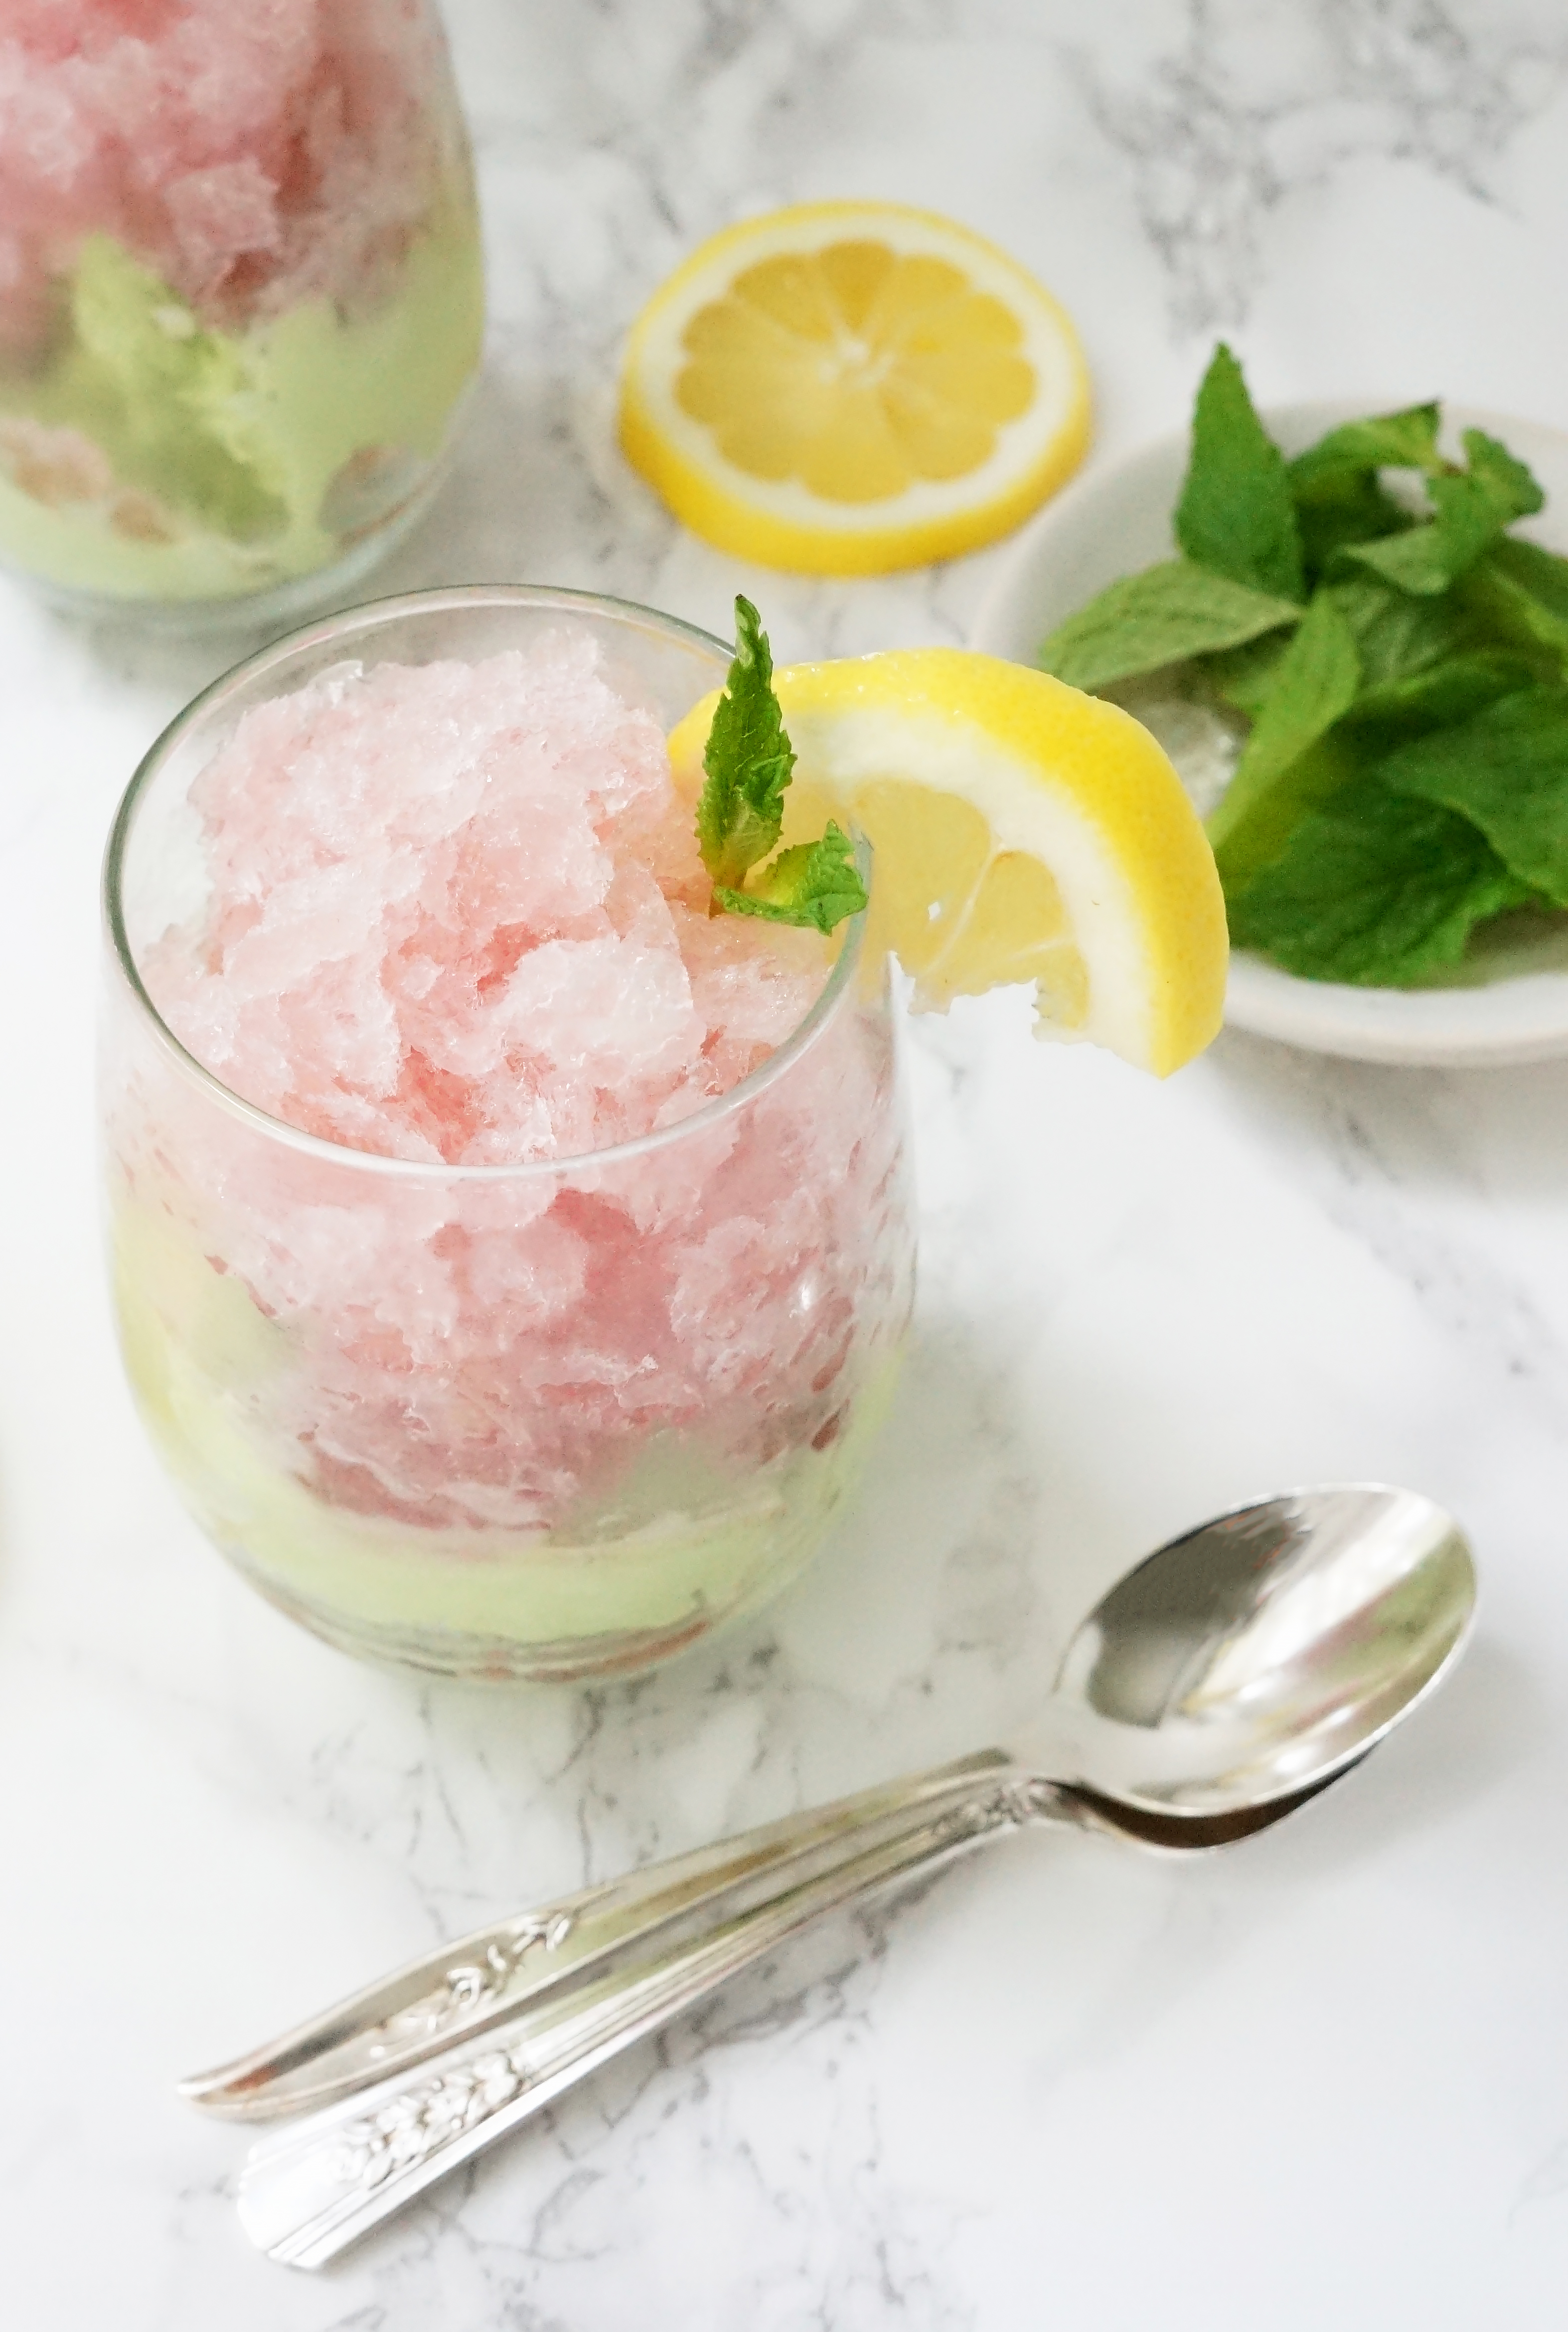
[{"x1": 0, "y1": 0, "x2": 1568, "y2": 2332}]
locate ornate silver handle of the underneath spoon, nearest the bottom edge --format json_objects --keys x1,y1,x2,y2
[{"x1": 240, "y1": 1763, "x2": 1064, "y2": 2267}]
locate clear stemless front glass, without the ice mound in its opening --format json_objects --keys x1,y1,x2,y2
[{"x1": 100, "y1": 588, "x2": 915, "y2": 1679}]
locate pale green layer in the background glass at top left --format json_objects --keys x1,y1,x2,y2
[{"x1": 0, "y1": 193, "x2": 483, "y2": 602}]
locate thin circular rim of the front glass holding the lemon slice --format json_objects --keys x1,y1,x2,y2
[{"x1": 100, "y1": 583, "x2": 870, "y2": 1182}]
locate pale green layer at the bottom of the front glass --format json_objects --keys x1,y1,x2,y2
[{"x1": 114, "y1": 1201, "x2": 898, "y2": 1677}]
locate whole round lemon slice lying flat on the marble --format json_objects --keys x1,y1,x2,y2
[{"x1": 621, "y1": 203, "x2": 1090, "y2": 574}]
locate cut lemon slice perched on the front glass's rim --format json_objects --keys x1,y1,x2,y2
[{"x1": 670, "y1": 648, "x2": 1227, "y2": 1078}]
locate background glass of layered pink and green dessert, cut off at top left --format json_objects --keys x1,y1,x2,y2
[{"x1": 0, "y1": 0, "x2": 483, "y2": 625}]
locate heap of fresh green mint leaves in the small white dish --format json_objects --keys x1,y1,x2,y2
[{"x1": 1041, "y1": 345, "x2": 1568, "y2": 986}]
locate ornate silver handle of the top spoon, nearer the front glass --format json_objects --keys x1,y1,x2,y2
[{"x1": 179, "y1": 1749, "x2": 1010, "y2": 2122}]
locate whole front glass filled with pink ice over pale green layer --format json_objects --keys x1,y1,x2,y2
[{"x1": 105, "y1": 592, "x2": 912, "y2": 1675}]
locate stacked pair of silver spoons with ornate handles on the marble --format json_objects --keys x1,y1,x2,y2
[{"x1": 192, "y1": 1486, "x2": 1475, "y2": 2267}]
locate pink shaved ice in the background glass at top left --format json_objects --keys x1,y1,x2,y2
[{"x1": 0, "y1": 0, "x2": 436, "y2": 352}]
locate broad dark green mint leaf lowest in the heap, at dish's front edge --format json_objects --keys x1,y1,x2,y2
[{"x1": 1227, "y1": 781, "x2": 1531, "y2": 986}]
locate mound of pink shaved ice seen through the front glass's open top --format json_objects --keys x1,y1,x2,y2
[{"x1": 145, "y1": 632, "x2": 828, "y2": 1166}]
